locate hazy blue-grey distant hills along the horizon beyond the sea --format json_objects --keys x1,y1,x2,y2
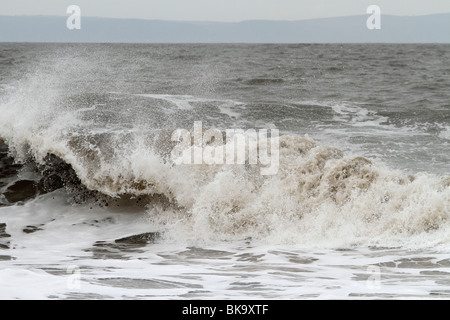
[{"x1": 0, "y1": 13, "x2": 450, "y2": 43}]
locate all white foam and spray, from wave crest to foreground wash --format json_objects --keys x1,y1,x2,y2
[{"x1": 0, "y1": 45, "x2": 450, "y2": 299}]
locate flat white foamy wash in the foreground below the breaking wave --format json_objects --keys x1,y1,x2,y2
[{"x1": 0, "y1": 191, "x2": 450, "y2": 299}]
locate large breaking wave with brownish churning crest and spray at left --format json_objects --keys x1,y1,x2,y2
[{"x1": 0, "y1": 61, "x2": 450, "y2": 246}]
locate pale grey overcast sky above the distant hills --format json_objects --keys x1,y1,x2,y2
[{"x1": 0, "y1": 0, "x2": 450, "y2": 21}]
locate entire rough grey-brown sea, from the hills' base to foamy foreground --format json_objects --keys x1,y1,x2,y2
[{"x1": 0, "y1": 44, "x2": 450, "y2": 299}]
